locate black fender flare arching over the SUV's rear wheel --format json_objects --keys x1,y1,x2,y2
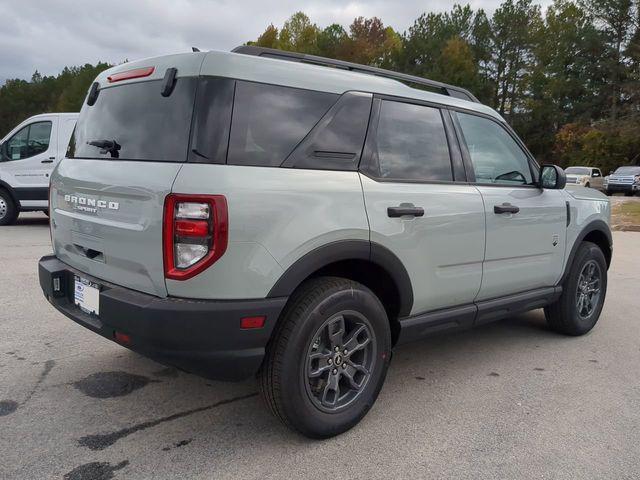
[{"x1": 267, "y1": 240, "x2": 413, "y2": 317}]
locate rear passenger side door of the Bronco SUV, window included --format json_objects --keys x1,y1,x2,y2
[{"x1": 361, "y1": 98, "x2": 485, "y2": 314}]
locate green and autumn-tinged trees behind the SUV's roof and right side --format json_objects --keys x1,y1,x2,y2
[{"x1": 250, "y1": 0, "x2": 640, "y2": 171}]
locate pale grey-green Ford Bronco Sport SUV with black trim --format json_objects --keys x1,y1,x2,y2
[{"x1": 39, "y1": 47, "x2": 612, "y2": 438}]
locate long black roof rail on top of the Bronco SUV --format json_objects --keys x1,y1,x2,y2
[{"x1": 231, "y1": 45, "x2": 480, "y2": 103}]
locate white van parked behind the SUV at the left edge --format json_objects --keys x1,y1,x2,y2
[{"x1": 0, "y1": 113, "x2": 78, "y2": 226}]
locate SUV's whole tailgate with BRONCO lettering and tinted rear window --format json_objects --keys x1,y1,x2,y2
[{"x1": 51, "y1": 71, "x2": 197, "y2": 296}]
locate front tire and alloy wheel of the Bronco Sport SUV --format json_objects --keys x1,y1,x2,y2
[{"x1": 544, "y1": 242, "x2": 607, "y2": 336}]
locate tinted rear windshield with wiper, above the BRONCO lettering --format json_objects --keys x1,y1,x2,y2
[{"x1": 67, "y1": 78, "x2": 197, "y2": 162}]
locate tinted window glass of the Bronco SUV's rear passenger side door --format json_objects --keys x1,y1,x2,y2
[{"x1": 371, "y1": 100, "x2": 453, "y2": 181}]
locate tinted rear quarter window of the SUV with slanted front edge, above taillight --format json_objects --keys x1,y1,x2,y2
[{"x1": 227, "y1": 81, "x2": 338, "y2": 167}]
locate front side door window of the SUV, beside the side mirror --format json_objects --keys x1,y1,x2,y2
[{"x1": 457, "y1": 113, "x2": 533, "y2": 185}]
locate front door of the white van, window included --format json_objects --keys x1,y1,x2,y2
[{"x1": 0, "y1": 115, "x2": 58, "y2": 207}]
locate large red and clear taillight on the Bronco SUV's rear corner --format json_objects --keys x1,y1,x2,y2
[{"x1": 163, "y1": 194, "x2": 229, "y2": 280}]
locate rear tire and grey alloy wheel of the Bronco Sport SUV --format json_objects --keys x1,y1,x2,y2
[{"x1": 258, "y1": 277, "x2": 391, "y2": 438}]
